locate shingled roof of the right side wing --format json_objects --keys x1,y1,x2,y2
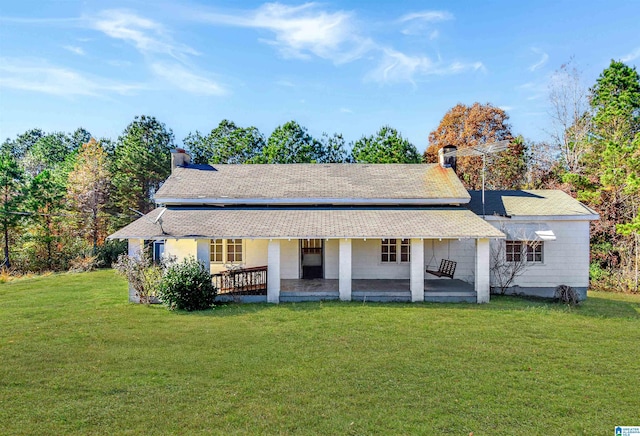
[{"x1": 468, "y1": 189, "x2": 598, "y2": 219}]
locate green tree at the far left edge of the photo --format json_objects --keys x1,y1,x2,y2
[{"x1": 0, "y1": 153, "x2": 24, "y2": 268}]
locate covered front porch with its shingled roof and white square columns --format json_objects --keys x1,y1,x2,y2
[{"x1": 114, "y1": 207, "x2": 504, "y2": 303}]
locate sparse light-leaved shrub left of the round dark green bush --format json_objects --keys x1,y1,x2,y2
[{"x1": 113, "y1": 251, "x2": 162, "y2": 304}]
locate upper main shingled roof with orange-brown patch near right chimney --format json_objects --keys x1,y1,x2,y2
[{"x1": 155, "y1": 164, "x2": 469, "y2": 205}]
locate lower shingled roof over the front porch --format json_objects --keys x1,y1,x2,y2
[{"x1": 109, "y1": 207, "x2": 504, "y2": 239}]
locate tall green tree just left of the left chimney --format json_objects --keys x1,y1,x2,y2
[{"x1": 111, "y1": 115, "x2": 174, "y2": 215}]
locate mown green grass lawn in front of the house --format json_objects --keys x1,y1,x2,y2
[{"x1": 0, "y1": 271, "x2": 640, "y2": 436}]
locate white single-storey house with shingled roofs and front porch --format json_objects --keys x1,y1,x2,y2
[{"x1": 110, "y1": 150, "x2": 597, "y2": 303}]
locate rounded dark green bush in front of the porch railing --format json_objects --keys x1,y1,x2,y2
[{"x1": 158, "y1": 257, "x2": 217, "y2": 311}]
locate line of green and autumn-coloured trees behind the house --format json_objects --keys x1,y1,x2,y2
[{"x1": 0, "y1": 61, "x2": 640, "y2": 290}]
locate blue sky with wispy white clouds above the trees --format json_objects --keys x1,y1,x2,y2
[{"x1": 0, "y1": 0, "x2": 640, "y2": 151}]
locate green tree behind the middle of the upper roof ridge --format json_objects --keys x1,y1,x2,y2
[{"x1": 255, "y1": 121, "x2": 324, "y2": 164}]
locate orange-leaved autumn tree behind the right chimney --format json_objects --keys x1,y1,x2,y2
[{"x1": 423, "y1": 103, "x2": 526, "y2": 189}]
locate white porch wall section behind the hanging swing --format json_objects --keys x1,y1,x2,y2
[{"x1": 424, "y1": 239, "x2": 476, "y2": 283}]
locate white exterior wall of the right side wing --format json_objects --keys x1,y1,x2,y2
[{"x1": 490, "y1": 220, "x2": 589, "y2": 298}]
